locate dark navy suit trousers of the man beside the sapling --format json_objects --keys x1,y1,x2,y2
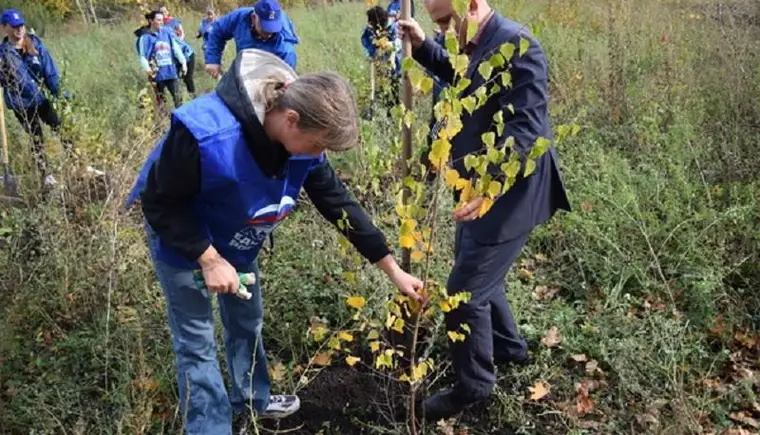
[{"x1": 446, "y1": 221, "x2": 530, "y2": 400}]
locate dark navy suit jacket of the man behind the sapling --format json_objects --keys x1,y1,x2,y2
[{"x1": 413, "y1": 13, "x2": 570, "y2": 244}]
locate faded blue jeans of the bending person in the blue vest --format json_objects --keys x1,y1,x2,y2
[{"x1": 150, "y1": 241, "x2": 270, "y2": 435}]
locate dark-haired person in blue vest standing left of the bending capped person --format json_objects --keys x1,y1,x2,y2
[{"x1": 135, "y1": 11, "x2": 187, "y2": 107}]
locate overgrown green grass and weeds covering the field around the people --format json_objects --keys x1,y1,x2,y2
[{"x1": 0, "y1": 0, "x2": 760, "y2": 435}]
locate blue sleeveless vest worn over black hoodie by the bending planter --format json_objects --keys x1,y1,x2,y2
[{"x1": 127, "y1": 92, "x2": 324, "y2": 269}]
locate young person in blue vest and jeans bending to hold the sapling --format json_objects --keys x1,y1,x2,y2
[{"x1": 127, "y1": 49, "x2": 422, "y2": 434}]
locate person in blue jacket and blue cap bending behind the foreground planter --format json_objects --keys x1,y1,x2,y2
[{"x1": 204, "y1": 0, "x2": 300, "y2": 78}]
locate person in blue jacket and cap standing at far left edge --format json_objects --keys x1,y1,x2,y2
[{"x1": 0, "y1": 9, "x2": 71, "y2": 187}]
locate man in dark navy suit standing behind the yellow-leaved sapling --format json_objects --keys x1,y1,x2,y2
[{"x1": 399, "y1": 0, "x2": 570, "y2": 420}]
